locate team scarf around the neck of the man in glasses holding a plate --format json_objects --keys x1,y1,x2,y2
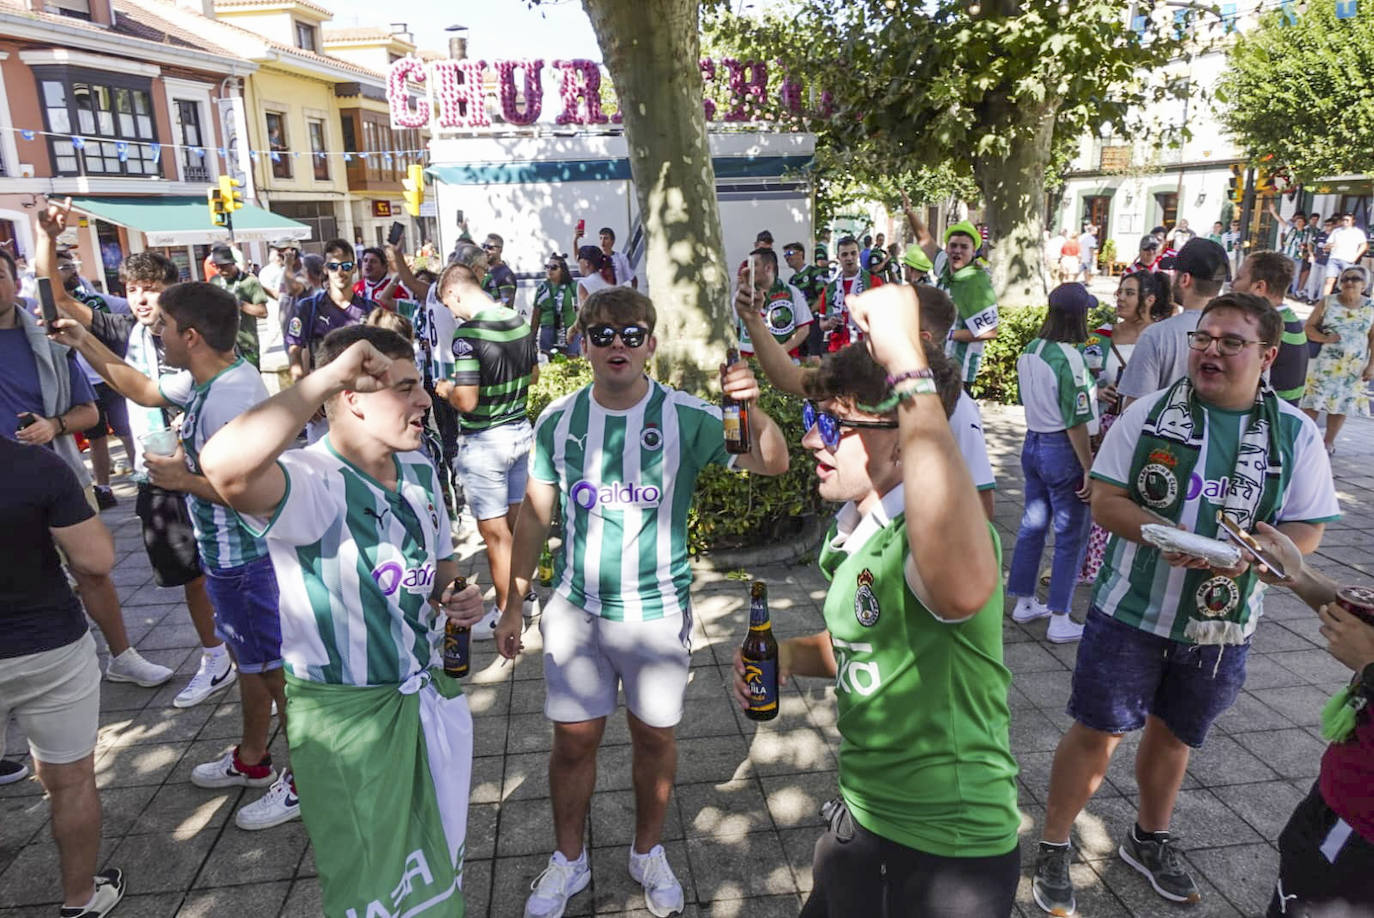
[{"x1": 1128, "y1": 377, "x2": 1289, "y2": 645}]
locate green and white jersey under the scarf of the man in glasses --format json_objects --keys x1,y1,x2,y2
[{"x1": 1092, "y1": 389, "x2": 1340, "y2": 643}]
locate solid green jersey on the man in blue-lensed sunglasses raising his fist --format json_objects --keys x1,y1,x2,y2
[{"x1": 819, "y1": 485, "x2": 1021, "y2": 858}]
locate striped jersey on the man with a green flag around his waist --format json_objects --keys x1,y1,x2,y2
[{"x1": 251, "y1": 436, "x2": 453, "y2": 686}]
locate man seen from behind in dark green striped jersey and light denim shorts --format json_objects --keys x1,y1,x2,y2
[{"x1": 434, "y1": 243, "x2": 539, "y2": 639}]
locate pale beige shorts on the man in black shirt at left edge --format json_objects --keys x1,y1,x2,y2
[{"x1": 0, "y1": 632, "x2": 100, "y2": 765}]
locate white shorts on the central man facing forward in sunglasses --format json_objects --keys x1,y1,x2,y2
[{"x1": 539, "y1": 594, "x2": 691, "y2": 727}]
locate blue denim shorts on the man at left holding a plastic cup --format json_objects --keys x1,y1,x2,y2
[{"x1": 205, "y1": 558, "x2": 282, "y2": 672}]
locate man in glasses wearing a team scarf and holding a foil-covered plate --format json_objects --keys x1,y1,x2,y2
[{"x1": 1032, "y1": 292, "x2": 1340, "y2": 915}]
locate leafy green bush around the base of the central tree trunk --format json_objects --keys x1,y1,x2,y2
[{"x1": 529, "y1": 360, "x2": 826, "y2": 555}]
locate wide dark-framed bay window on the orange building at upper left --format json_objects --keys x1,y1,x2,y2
[{"x1": 34, "y1": 67, "x2": 162, "y2": 176}]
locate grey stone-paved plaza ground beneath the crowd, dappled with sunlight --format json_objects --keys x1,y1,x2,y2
[{"x1": 0, "y1": 407, "x2": 1374, "y2": 918}]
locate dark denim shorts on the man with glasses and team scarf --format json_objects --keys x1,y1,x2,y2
[{"x1": 1068, "y1": 607, "x2": 1250, "y2": 748}]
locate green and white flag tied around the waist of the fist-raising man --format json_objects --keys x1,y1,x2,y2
[{"x1": 286, "y1": 671, "x2": 473, "y2": 918}]
